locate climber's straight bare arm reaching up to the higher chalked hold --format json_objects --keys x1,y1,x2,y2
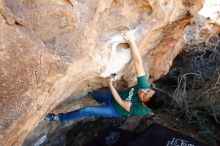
[{"x1": 123, "y1": 32, "x2": 145, "y2": 77}]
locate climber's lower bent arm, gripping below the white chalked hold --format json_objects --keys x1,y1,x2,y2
[{"x1": 107, "y1": 78, "x2": 131, "y2": 112}]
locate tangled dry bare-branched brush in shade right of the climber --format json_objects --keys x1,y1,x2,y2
[{"x1": 172, "y1": 34, "x2": 220, "y2": 145}]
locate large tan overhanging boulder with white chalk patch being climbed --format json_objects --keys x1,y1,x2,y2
[{"x1": 0, "y1": 0, "x2": 203, "y2": 146}]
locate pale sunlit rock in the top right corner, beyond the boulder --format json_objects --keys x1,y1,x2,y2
[{"x1": 184, "y1": 0, "x2": 220, "y2": 46}]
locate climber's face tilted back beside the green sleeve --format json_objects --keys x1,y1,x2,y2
[{"x1": 138, "y1": 89, "x2": 155, "y2": 103}]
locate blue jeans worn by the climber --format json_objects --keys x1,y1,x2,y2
[{"x1": 58, "y1": 91, "x2": 121, "y2": 122}]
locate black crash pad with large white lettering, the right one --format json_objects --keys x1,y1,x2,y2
[{"x1": 127, "y1": 124, "x2": 207, "y2": 146}]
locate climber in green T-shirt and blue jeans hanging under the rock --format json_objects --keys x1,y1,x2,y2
[{"x1": 44, "y1": 32, "x2": 155, "y2": 122}]
